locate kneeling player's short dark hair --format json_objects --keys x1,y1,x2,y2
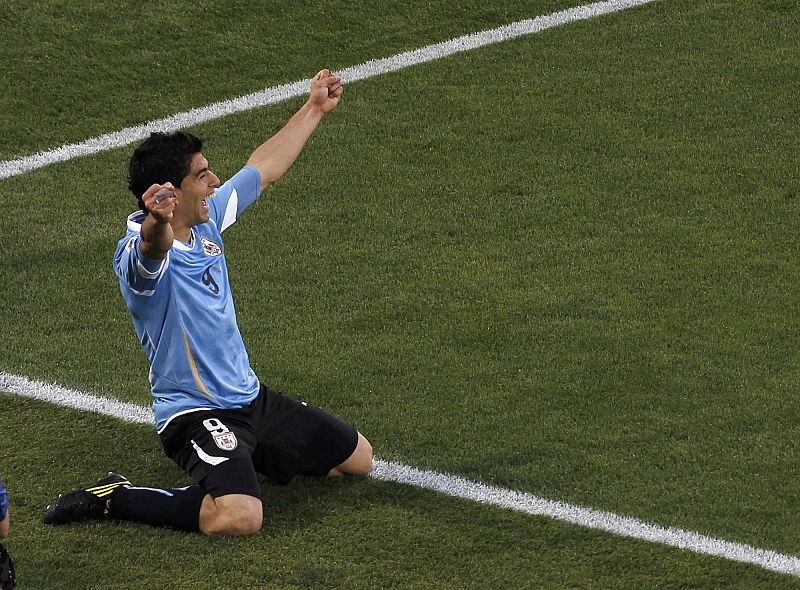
[{"x1": 128, "y1": 131, "x2": 203, "y2": 211}]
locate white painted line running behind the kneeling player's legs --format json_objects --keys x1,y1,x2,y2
[{"x1": 0, "y1": 371, "x2": 800, "y2": 577}]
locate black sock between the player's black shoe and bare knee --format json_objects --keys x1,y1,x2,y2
[{"x1": 108, "y1": 485, "x2": 208, "y2": 532}]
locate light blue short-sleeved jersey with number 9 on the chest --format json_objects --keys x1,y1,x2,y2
[{"x1": 114, "y1": 167, "x2": 261, "y2": 433}]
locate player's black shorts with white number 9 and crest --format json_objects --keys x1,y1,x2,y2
[{"x1": 160, "y1": 385, "x2": 358, "y2": 499}]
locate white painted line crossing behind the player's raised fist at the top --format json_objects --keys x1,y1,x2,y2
[{"x1": 0, "y1": 0, "x2": 655, "y2": 180}]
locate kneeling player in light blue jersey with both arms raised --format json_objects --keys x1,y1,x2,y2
[{"x1": 45, "y1": 70, "x2": 372, "y2": 535}]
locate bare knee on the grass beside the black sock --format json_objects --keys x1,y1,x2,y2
[{"x1": 200, "y1": 494, "x2": 264, "y2": 536}]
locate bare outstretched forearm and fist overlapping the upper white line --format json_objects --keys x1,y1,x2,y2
[{"x1": 247, "y1": 70, "x2": 344, "y2": 191}]
